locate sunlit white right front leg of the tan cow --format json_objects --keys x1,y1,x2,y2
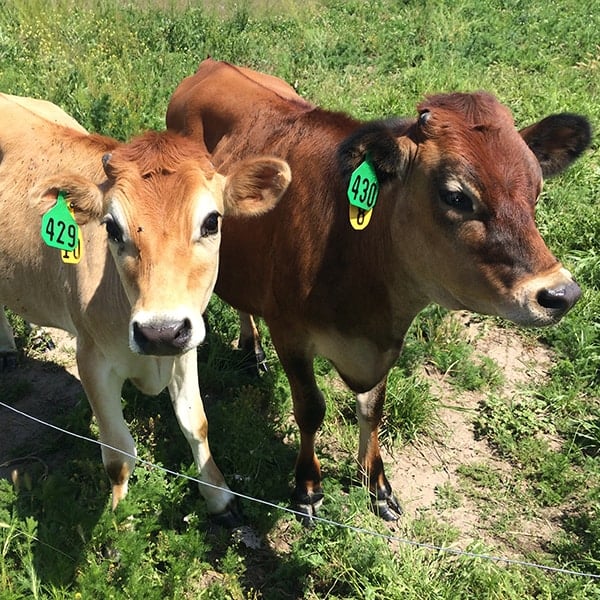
[{"x1": 169, "y1": 350, "x2": 241, "y2": 527}]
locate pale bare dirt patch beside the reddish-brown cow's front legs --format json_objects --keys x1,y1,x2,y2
[{"x1": 384, "y1": 313, "x2": 557, "y2": 556}]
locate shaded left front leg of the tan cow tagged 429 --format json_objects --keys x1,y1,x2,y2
[{"x1": 77, "y1": 336, "x2": 136, "y2": 510}]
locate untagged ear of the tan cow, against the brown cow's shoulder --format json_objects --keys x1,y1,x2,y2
[{"x1": 223, "y1": 157, "x2": 292, "y2": 216}]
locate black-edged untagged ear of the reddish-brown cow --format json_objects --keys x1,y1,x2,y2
[{"x1": 519, "y1": 113, "x2": 592, "y2": 177}]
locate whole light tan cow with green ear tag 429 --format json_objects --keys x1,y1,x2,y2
[{"x1": 0, "y1": 91, "x2": 290, "y2": 521}]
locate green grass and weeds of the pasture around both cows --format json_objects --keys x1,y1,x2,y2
[{"x1": 0, "y1": 0, "x2": 600, "y2": 600}]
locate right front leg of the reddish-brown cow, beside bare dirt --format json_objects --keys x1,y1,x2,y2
[{"x1": 356, "y1": 376, "x2": 402, "y2": 521}]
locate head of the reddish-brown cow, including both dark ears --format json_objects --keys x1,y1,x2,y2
[{"x1": 340, "y1": 93, "x2": 591, "y2": 326}]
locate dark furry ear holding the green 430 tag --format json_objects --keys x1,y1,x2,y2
[{"x1": 338, "y1": 121, "x2": 414, "y2": 184}]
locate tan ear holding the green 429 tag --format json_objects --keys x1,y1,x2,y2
[{"x1": 30, "y1": 174, "x2": 104, "y2": 225}]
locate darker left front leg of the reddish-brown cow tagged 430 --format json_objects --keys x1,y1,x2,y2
[{"x1": 269, "y1": 324, "x2": 325, "y2": 525}]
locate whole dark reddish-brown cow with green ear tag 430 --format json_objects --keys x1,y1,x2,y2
[{"x1": 167, "y1": 59, "x2": 590, "y2": 519}]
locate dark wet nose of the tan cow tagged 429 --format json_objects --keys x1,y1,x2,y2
[{"x1": 132, "y1": 318, "x2": 192, "y2": 356}]
